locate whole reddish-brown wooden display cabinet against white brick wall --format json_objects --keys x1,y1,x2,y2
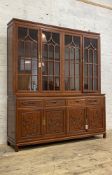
[{"x1": 7, "y1": 19, "x2": 106, "y2": 151}]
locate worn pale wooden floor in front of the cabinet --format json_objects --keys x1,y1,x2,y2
[{"x1": 0, "y1": 131, "x2": 112, "y2": 175}]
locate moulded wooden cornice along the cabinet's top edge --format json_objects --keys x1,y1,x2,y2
[{"x1": 7, "y1": 18, "x2": 100, "y2": 36}]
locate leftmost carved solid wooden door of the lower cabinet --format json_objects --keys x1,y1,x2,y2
[{"x1": 17, "y1": 109, "x2": 42, "y2": 141}]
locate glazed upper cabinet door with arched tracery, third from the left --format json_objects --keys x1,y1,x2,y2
[{"x1": 64, "y1": 34, "x2": 81, "y2": 91}]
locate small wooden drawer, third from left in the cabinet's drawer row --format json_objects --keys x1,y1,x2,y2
[{"x1": 68, "y1": 98, "x2": 85, "y2": 106}]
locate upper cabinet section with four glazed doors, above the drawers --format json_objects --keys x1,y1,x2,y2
[{"x1": 8, "y1": 19, "x2": 100, "y2": 96}]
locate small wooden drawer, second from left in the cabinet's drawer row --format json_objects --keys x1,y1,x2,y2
[{"x1": 45, "y1": 99, "x2": 65, "y2": 107}]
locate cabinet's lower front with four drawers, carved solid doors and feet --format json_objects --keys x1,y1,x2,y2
[{"x1": 8, "y1": 96, "x2": 106, "y2": 151}]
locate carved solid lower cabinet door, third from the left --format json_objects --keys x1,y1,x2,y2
[{"x1": 68, "y1": 106, "x2": 85, "y2": 135}]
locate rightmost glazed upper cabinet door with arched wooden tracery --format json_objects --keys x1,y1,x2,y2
[{"x1": 83, "y1": 37, "x2": 100, "y2": 92}]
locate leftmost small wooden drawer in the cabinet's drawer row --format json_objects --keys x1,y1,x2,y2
[{"x1": 17, "y1": 100, "x2": 43, "y2": 108}]
